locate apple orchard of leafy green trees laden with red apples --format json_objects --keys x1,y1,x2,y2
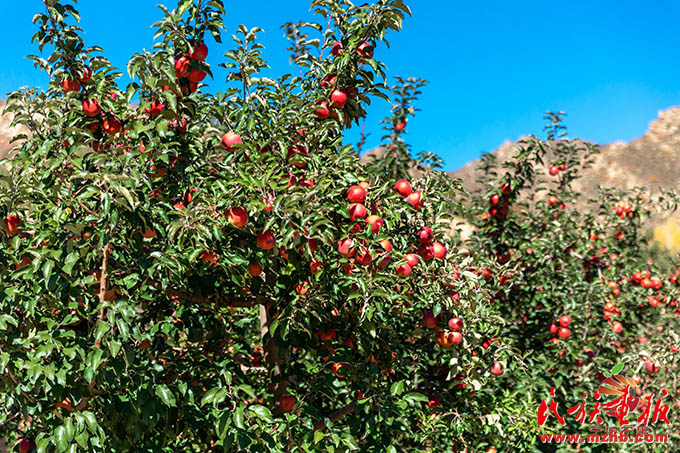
[{"x1": 0, "y1": 0, "x2": 680, "y2": 453}]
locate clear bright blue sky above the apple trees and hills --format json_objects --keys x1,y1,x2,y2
[{"x1": 0, "y1": 0, "x2": 680, "y2": 170}]
